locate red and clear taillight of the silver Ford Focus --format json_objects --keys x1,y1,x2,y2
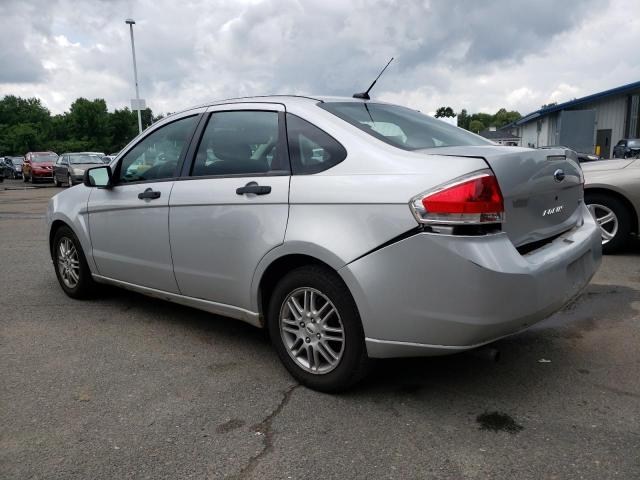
[{"x1": 409, "y1": 170, "x2": 504, "y2": 225}]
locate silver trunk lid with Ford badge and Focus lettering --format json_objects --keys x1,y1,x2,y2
[{"x1": 422, "y1": 145, "x2": 583, "y2": 247}]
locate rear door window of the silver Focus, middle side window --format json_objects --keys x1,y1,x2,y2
[{"x1": 191, "y1": 110, "x2": 288, "y2": 177}]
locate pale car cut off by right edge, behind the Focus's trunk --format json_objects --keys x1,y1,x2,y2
[{"x1": 582, "y1": 159, "x2": 640, "y2": 253}]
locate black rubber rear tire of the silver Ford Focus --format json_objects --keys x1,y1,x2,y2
[{"x1": 267, "y1": 265, "x2": 370, "y2": 392}]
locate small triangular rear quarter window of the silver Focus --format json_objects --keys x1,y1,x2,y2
[{"x1": 287, "y1": 113, "x2": 347, "y2": 175}]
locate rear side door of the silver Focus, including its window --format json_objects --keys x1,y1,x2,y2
[{"x1": 169, "y1": 103, "x2": 290, "y2": 309}]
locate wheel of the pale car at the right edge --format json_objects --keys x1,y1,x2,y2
[{"x1": 585, "y1": 193, "x2": 631, "y2": 253}]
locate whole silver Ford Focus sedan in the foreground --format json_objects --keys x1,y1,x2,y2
[{"x1": 47, "y1": 96, "x2": 601, "y2": 391}]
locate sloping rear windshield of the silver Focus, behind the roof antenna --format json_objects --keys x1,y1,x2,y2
[{"x1": 318, "y1": 102, "x2": 491, "y2": 150}]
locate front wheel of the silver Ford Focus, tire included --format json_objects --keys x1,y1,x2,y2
[{"x1": 52, "y1": 226, "x2": 95, "y2": 298}]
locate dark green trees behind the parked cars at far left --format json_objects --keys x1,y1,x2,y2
[{"x1": 0, "y1": 95, "x2": 162, "y2": 156}]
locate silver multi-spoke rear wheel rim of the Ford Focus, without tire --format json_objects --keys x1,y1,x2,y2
[{"x1": 280, "y1": 287, "x2": 344, "y2": 374}]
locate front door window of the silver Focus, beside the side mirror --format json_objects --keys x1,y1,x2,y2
[{"x1": 117, "y1": 115, "x2": 197, "y2": 183}]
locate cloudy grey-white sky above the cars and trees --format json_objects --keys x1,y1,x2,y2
[{"x1": 0, "y1": 0, "x2": 640, "y2": 114}]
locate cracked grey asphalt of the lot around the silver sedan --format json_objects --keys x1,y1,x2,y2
[{"x1": 0, "y1": 182, "x2": 640, "y2": 479}]
